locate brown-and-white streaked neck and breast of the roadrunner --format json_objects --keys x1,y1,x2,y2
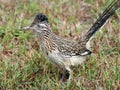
[{"x1": 40, "y1": 25, "x2": 56, "y2": 54}]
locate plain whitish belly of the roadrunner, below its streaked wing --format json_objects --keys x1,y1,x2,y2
[{"x1": 48, "y1": 51, "x2": 86, "y2": 67}]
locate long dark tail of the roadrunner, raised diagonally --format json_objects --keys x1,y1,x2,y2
[{"x1": 80, "y1": 0, "x2": 120, "y2": 44}]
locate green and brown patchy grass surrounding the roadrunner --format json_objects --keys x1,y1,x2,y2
[{"x1": 0, "y1": 0, "x2": 120, "y2": 90}]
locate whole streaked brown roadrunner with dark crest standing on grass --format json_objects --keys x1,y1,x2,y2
[{"x1": 23, "y1": 0, "x2": 120, "y2": 80}]
